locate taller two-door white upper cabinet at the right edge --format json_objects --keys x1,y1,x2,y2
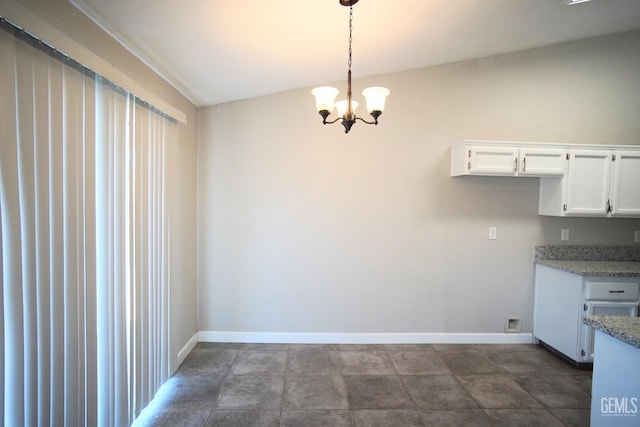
[{"x1": 538, "y1": 150, "x2": 640, "y2": 217}]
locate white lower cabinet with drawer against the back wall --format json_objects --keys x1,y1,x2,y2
[{"x1": 533, "y1": 265, "x2": 640, "y2": 364}]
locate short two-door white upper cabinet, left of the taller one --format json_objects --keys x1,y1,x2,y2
[{"x1": 451, "y1": 141, "x2": 567, "y2": 177}]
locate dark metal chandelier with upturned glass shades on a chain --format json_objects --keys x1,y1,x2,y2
[{"x1": 311, "y1": 0, "x2": 390, "y2": 133}]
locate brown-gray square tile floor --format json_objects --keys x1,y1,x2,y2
[{"x1": 134, "y1": 343, "x2": 591, "y2": 427}]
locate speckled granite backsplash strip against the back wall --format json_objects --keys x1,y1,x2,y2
[{"x1": 533, "y1": 245, "x2": 640, "y2": 262}]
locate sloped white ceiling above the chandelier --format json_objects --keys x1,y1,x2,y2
[{"x1": 70, "y1": 0, "x2": 640, "y2": 106}]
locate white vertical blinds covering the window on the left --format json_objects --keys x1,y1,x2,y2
[{"x1": 0, "y1": 18, "x2": 177, "y2": 426}]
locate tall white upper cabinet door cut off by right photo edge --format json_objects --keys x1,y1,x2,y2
[{"x1": 611, "y1": 151, "x2": 640, "y2": 217}]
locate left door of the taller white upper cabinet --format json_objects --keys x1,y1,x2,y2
[{"x1": 564, "y1": 150, "x2": 613, "y2": 217}]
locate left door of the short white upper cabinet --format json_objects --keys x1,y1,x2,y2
[{"x1": 468, "y1": 146, "x2": 518, "y2": 176}]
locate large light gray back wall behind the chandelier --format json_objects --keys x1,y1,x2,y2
[{"x1": 198, "y1": 32, "x2": 640, "y2": 333}]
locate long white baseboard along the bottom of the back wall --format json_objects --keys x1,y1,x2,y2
[{"x1": 198, "y1": 331, "x2": 535, "y2": 344}]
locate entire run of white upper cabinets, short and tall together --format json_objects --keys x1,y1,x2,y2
[{"x1": 451, "y1": 140, "x2": 640, "y2": 218}]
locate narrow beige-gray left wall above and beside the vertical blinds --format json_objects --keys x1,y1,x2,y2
[{"x1": 9, "y1": 0, "x2": 197, "y2": 369}]
